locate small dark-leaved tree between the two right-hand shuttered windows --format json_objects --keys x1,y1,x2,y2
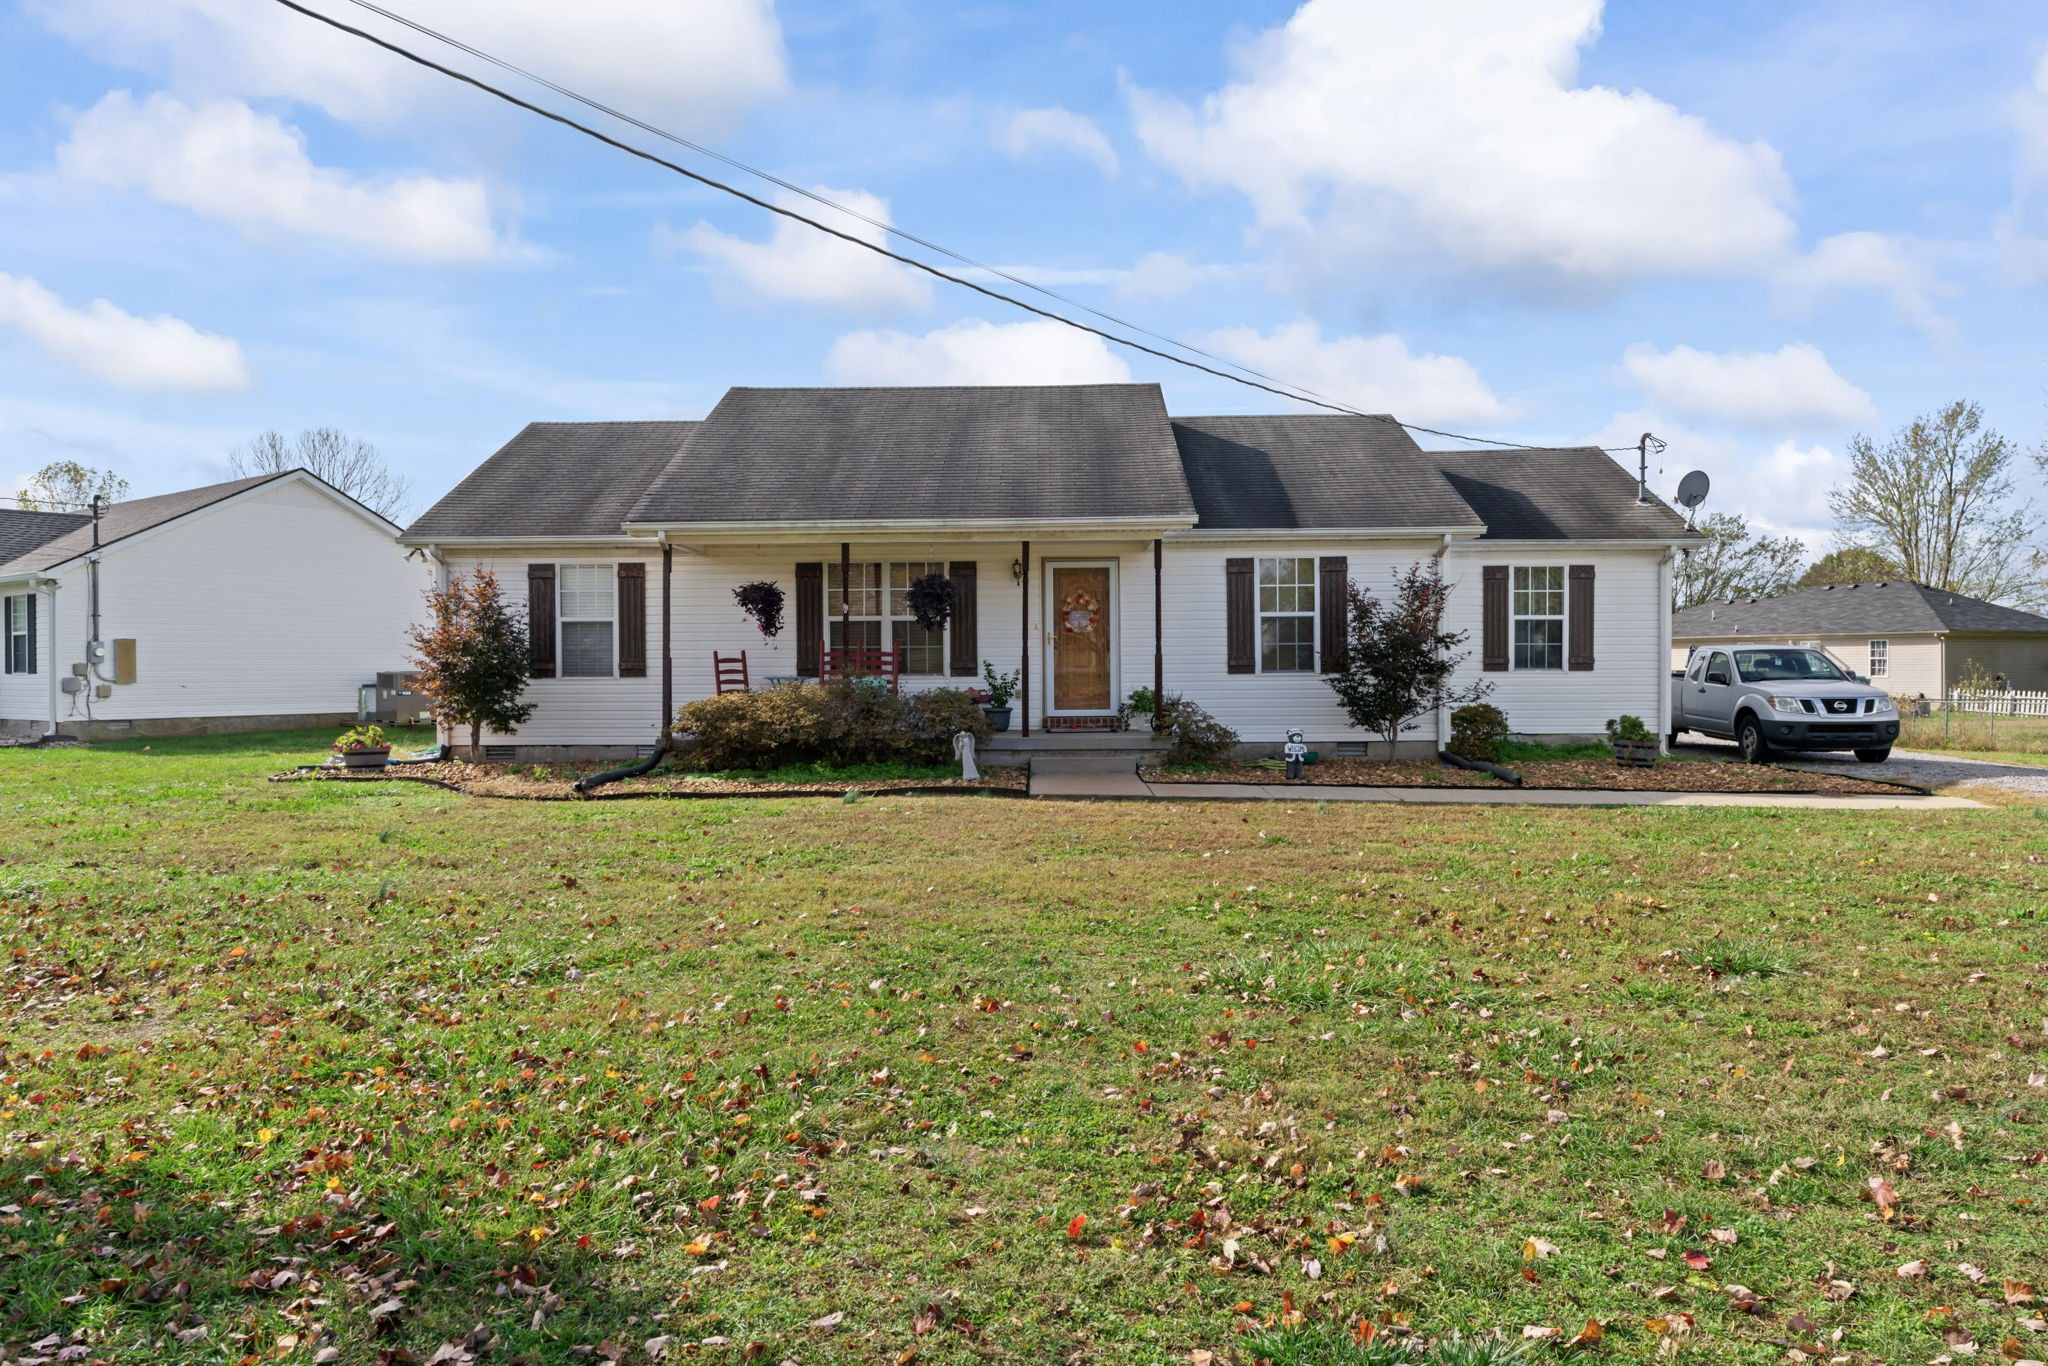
[{"x1": 1329, "y1": 561, "x2": 1493, "y2": 758}]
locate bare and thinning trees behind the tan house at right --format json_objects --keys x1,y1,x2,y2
[{"x1": 1671, "y1": 401, "x2": 2048, "y2": 608}]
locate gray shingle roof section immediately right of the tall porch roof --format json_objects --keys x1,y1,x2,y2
[{"x1": 1174, "y1": 414, "x2": 1483, "y2": 530}]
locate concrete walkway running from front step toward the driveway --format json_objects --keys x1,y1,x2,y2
[{"x1": 1030, "y1": 770, "x2": 1987, "y2": 811}]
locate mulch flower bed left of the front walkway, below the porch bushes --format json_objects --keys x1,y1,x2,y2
[{"x1": 270, "y1": 760, "x2": 1026, "y2": 801}]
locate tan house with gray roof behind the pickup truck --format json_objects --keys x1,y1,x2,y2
[{"x1": 1671, "y1": 580, "x2": 2048, "y2": 696}]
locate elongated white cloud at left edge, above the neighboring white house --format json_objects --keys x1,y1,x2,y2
[{"x1": 0, "y1": 274, "x2": 250, "y2": 393}]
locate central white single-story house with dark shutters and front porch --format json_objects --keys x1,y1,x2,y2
[{"x1": 401, "y1": 385, "x2": 1694, "y2": 758}]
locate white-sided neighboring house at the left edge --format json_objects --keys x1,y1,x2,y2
[{"x1": 0, "y1": 469, "x2": 432, "y2": 739}]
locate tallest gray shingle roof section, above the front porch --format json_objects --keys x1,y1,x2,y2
[{"x1": 627, "y1": 385, "x2": 1194, "y2": 524}]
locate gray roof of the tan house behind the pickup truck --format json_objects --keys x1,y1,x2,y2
[{"x1": 1671, "y1": 580, "x2": 2048, "y2": 639}]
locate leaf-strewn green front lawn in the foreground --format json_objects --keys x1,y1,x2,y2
[{"x1": 0, "y1": 735, "x2": 2048, "y2": 1366}]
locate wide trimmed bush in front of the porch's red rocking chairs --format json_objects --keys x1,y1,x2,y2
[{"x1": 674, "y1": 678, "x2": 993, "y2": 768}]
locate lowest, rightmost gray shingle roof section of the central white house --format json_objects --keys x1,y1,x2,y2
[{"x1": 1423, "y1": 446, "x2": 1694, "y2": 541}]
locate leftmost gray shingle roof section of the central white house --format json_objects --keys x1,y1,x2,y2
[{"x1": 406, "y1": 422, "x2": 700, "y2": 541}]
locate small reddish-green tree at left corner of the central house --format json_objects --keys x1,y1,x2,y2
[{"x1": 412, "y1": 569, "x2": 532, "y2": 760}]
